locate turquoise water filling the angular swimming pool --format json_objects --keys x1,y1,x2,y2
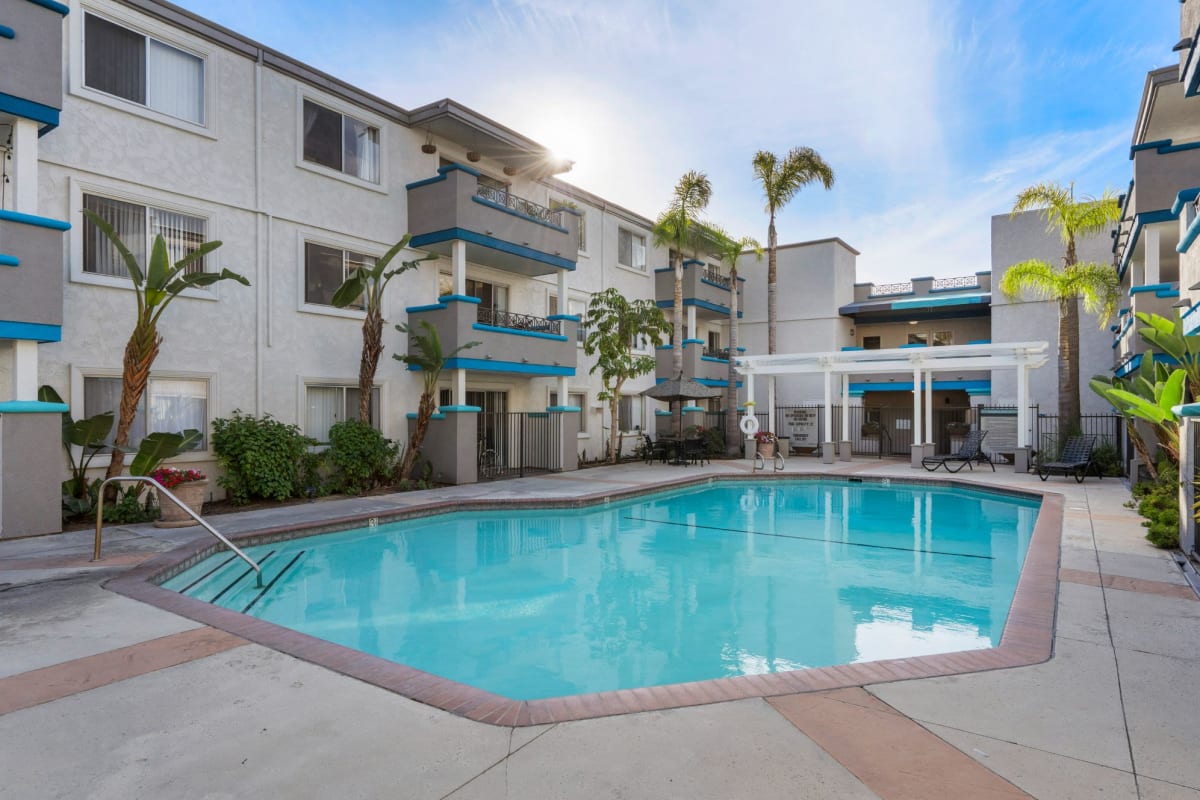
[{"x1": 163, "y1": 480, "x2": 1039, "y2": 699}]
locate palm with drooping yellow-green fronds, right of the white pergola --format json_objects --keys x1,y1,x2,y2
[{"x1": 1000, "y1": 184, "x2": 1121, "y2": 433}]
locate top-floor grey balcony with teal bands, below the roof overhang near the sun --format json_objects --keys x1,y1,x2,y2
[{"x1": 407, "y1": 164, "x2": 580, "y2": 276}]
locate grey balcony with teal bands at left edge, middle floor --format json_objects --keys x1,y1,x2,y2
[{"x1": 0, "y1": 211, "x2": 71, "y2": 342}]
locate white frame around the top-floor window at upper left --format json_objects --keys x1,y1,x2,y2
[{"x1": 67, "y1": 0, "x2": 221, "y2": 139}]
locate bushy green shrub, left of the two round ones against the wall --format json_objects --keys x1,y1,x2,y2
[{"x1": 212, "y1": 410, "x2": 317, "y2": 505}]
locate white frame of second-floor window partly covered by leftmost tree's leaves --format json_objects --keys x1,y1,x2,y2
[{"x1": 68, "y1": 176, "x2": 224, "y2": 302}]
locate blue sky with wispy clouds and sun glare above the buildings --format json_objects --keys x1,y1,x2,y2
[{"x1": 176, "y1": 0, "x2": 1178, "y2": 283}]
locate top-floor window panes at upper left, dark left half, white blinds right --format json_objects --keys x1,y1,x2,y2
[{"x1": 83, "y1": 13, "x2": 204, "y2": 125}]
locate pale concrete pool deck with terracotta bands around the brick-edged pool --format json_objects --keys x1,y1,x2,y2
[{"x1": 0, "y1": 458, "x2": 1200, "y2": 800}]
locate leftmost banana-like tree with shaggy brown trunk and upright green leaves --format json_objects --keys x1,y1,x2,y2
[{"x1": 84, "y1": 209, "x2": 250, "y2": 479}]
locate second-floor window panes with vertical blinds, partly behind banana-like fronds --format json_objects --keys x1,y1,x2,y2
[{"x1": 83, "y1": 194, "x2": 209, "y2": 278}]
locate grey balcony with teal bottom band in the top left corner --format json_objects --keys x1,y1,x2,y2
[{"x1": 0, "y1": 2, "x2": 67, "y2": 130}]
